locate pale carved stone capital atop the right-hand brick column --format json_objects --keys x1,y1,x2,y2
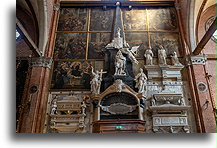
[{"x1": 186, "y1": 54, "x2": 207, "y2": 65}]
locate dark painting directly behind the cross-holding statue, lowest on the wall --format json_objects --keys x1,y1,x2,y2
[{"x1": 52, "y1": 61, "x2": 94, "y2": 89}]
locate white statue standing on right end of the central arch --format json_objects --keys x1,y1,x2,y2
[{"x1": 135, "y1": 68, "x2": 147, "y2": 93}]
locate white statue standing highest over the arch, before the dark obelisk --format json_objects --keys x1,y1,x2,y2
[{"x1": 115, "y1": 50, "x2": 126, "y2": 75}]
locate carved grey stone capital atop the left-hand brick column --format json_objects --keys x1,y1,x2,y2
[{"x1": 30, "y1": 57, "x2": 53, "y2": 68}]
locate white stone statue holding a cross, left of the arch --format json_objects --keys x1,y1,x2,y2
[{"x1": 90, "y1": 67, "x2": 102, "y2": 94}]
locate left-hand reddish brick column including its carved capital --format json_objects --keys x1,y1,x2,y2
[{"x1": 18, "y1": 57, "x2": 53, "y2": 133}]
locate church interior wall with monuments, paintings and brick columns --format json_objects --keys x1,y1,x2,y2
[{"x1": 16, "y1": 0, "x2": 217, "y2": 133}]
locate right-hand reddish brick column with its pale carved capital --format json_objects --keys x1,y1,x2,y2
[{"x1": 189, "y1": 55, "x2": 216, "y2": 133}]
